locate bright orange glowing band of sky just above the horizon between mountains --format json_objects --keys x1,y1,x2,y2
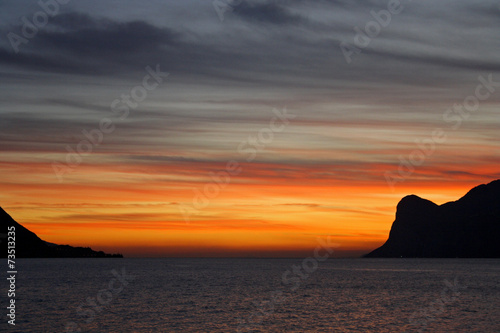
[{"x1": 3, "y1": 163, "x2": 492, "y2": 257}]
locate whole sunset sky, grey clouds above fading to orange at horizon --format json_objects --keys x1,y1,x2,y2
[{"x1": 0, "y1": 0, "x2": 500, "y2": 257}]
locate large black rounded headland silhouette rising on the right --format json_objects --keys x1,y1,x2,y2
[{"x1": 365, "y1": 180, "x2": 500, "y2": 258}]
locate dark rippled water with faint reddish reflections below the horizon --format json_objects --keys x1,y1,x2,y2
[{"x1": 0, "y1": 259, "x2": 500, "y2": 333}]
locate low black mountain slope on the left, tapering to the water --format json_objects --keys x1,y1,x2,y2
[{"x1": 0, "y1": 207, "x2": 123, "y2": 258}]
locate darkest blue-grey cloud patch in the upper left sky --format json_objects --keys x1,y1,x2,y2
[{"x1": 0, "y1": 13, "x2": 180, "y2": 75}]
